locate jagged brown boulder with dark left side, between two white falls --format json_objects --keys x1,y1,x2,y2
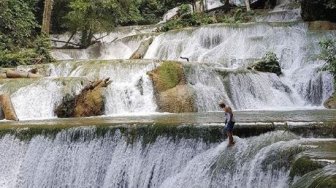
[{"x1": 55, "y1": 78, "x2": 111, "y2": 118}]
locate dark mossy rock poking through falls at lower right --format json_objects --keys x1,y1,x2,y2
[{"x1": 289, "y1": 156, "x2": 323, "y2": 179}]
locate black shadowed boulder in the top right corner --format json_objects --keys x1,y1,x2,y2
[{"x1": 301, "y1": 0, "x2": 336, "y2": 22}]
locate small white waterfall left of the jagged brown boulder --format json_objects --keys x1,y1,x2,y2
[{"x1": 0, "y1": 78, "x2": 86, "y2": 120}]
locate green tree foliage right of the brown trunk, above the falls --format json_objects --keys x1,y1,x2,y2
[{"x1": 65, "y1": 0, "x2": 140, "y2": 48}]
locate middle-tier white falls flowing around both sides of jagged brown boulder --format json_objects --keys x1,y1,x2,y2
[{"x1": 0, "y1": 60, "x2": 157, "y2": 120}]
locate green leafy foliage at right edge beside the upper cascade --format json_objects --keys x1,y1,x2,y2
[{"x1": 319, "y1": 39, "x2": 336, "y2": 83}]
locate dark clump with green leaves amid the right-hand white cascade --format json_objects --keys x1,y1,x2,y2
[{"x1": 247, "y1": 52, "x2": 282, "y2": 76}]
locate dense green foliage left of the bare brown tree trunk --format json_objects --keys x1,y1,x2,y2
[{"x1": 0, "y1": 0, "x2": 53, "y2": 67}]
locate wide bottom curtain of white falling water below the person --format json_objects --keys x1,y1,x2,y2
[{"x1": 0, "y1": 128, "x2": 330, "y2": 187}]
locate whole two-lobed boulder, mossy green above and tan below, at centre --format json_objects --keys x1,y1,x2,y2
[{"x1": 148, "y1": 62, "x2": 197, "y2": 113}]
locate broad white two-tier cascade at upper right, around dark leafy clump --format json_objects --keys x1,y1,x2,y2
[{"x1": 145, "y1": 23, "x2": 336, "y2": 111}]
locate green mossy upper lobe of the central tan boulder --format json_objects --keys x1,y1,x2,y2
[{"x1": 148, "y1": 61, "x2": 186, "y2": 92}]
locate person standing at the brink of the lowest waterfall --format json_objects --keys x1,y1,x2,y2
[{"x1": 219, "y1": 103, "x2": 236, "y2": 147}]
